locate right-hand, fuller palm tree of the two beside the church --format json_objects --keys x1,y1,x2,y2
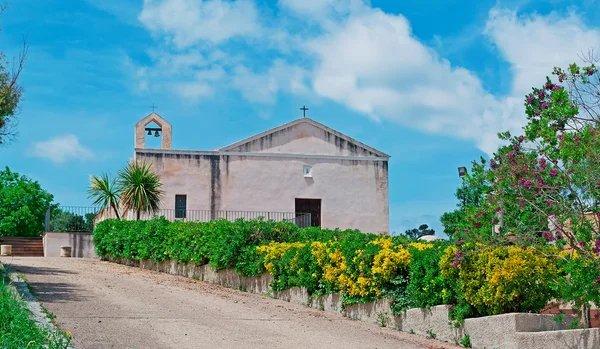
[{"x1": 118, "y1": 161, "x2": 163, "y2": 220}]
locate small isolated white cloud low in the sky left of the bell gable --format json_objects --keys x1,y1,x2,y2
[{"x1": 28, "y1": 134, "x2": 94, "y2": 164}]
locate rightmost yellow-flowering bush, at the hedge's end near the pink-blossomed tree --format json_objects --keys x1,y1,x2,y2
[{"x1": 440, "y1": 246, "x2": 560, "y2": 320}]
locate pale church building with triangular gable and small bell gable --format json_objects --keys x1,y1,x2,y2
[{"x1": 135, "y1": 113, "x2": 389, "y2": 234}]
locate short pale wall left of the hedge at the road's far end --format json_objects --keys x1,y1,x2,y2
[{"x1": 42, "y1": 233, "x2": 98, "y2": 258}]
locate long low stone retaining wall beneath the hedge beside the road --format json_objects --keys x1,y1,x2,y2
[{"x1": 108, "y1": 258, "x2": 600, "y2": 349}]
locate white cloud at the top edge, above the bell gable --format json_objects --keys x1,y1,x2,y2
[{"x1": 138, "y1": 0, "x2": 261, "y2": 48}]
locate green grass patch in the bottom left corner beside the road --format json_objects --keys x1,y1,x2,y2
[{"x1": 0, "y1": 265, "x2": 71, "y2": 349}]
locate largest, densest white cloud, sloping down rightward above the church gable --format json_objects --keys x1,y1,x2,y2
[{"x1": 308, "y1": 10, "x2": 505, "y2": 151}]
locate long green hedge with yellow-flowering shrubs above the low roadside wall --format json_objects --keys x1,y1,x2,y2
[{"x1": 94, "y1": 218, "x2": 566, "y2": 321}]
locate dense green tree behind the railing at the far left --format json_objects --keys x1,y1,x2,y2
[{"x1": 0, "y1": 167, "x2": 56, "y2": 236}]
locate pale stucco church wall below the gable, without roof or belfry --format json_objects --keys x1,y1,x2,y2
[{"x1": 136, "y1": 150, "x2": 389, "y2": 233}]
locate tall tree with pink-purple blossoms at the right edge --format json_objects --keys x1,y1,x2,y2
[{"x1": 455, "y1": 57, "x2": 600, "y2": 326}]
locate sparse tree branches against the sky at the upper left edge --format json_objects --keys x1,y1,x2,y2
[{"x1": 0, "y1": 6, "x2": 27, "y2": 144}]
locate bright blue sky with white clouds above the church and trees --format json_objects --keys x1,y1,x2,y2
[{"x1": 0, "y1": 0, "x2": 600, "y2": 232}]
